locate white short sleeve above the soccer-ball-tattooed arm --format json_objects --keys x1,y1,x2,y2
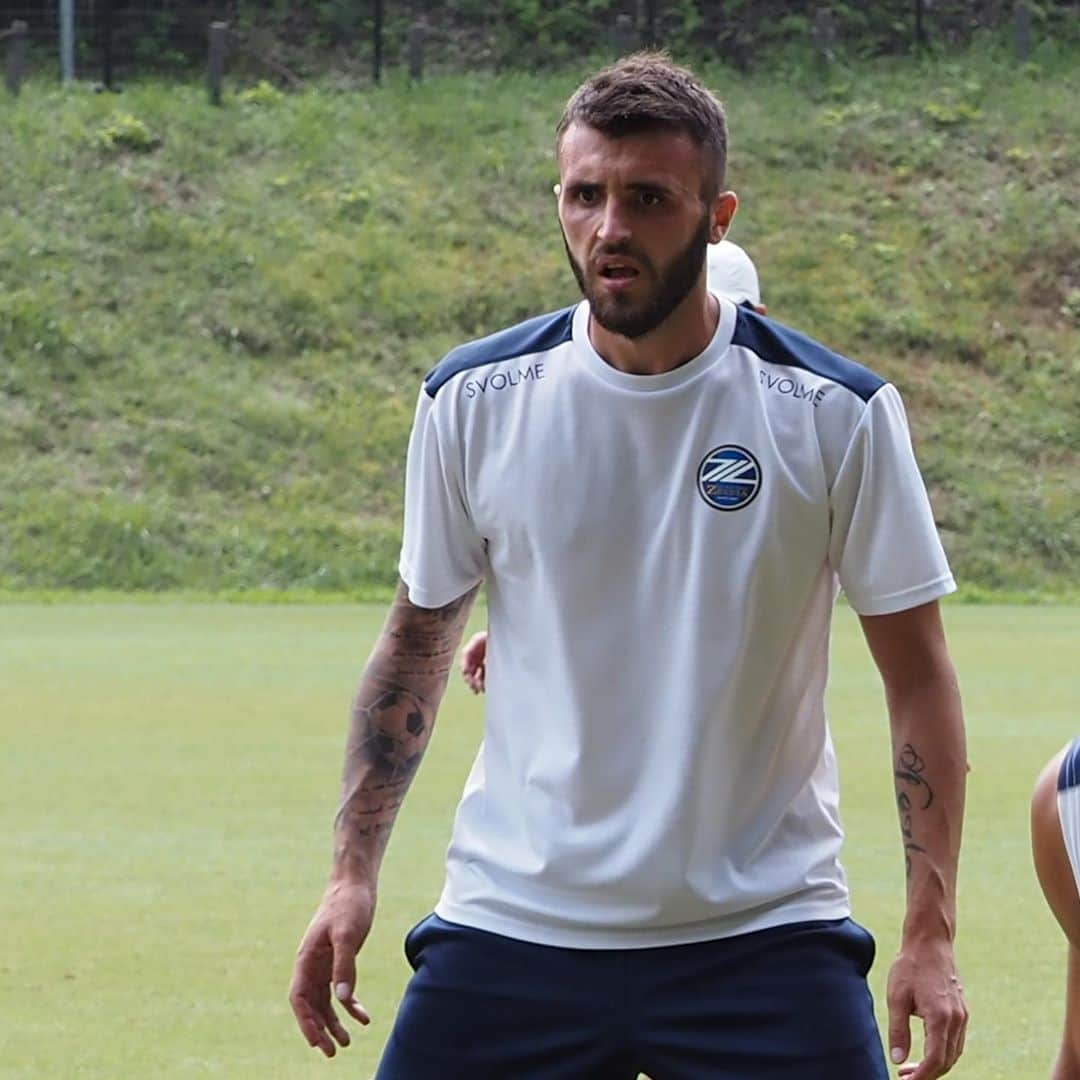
[{"x1": 399, "y1": 390, "x2": 486, "y2": 608}]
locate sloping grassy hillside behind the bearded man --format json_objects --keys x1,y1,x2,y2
[{"x1": 0, "y1": 44, "x2": 1080, "y2": 593}]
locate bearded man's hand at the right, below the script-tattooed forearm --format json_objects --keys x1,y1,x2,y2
[{"x1": 887, "y1": 941, "x2": 968, "y2": 1080}]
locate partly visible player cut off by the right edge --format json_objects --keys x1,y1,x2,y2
[{"x1": 1031, "y1": 739, "x2": 1080, "y2": 1080}]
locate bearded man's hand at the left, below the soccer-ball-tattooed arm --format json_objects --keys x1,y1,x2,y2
[{"x1": 288, "y1": 881, "x2": 375, "y2": 1057}]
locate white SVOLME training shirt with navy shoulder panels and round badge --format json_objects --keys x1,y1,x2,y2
[{"x1": 401, "y1": 300, "x2": 955, "y2": 948}]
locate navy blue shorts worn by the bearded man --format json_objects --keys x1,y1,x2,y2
[{"x1": 376, "y1": 915, "x2": 888, "y2": 1080}]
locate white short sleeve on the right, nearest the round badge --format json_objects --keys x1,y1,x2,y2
[{"x1": 829, "y1": 384, "x2": 956, "y2": 615}]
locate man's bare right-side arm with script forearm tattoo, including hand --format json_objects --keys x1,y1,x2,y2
[{"x1": 861, "y1": 600, "x2": 968, "y2": 1080}]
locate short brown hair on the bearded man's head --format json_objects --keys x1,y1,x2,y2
[{"x1": 555, "y1": 52, "x2": 728, "y2": 200}]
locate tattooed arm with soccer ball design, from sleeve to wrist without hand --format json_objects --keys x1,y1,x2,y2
[{"x1": 334, "y1": 584, "x2": 480, "y2": 877}]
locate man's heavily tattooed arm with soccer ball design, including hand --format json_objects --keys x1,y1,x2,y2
[{"x1": 289, "y1": 584, "x2": 480, "y2": 1057}]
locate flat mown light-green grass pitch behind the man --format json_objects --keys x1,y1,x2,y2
[{"x1": 0, "y1": 604, "x2": 1080, "y2": 1080}]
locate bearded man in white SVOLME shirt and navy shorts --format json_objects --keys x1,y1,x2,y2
[{"x1": 291, "y1": 54, "x2": 967, "y2": 1080}]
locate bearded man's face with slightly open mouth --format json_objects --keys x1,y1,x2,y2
[{"x1": 558, "y1": 124, "x2": 734, "y2": 338}]
